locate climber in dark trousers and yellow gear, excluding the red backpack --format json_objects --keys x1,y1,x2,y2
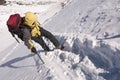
[{"x1": 8, "y1": 12, "x2": 63, "y2": 54}]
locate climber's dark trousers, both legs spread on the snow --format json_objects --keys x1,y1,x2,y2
[{"x1": 32, "y1": 28, "x2": 60, "y2": 51}]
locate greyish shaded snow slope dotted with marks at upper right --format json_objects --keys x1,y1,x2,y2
[{"x1": 45, "y1": 0, "x2": 120, "y2": 48}]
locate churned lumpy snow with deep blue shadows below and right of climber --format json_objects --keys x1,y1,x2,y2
[{"x1": 33, "y1": 33, "x2": 120, "y2": 80}]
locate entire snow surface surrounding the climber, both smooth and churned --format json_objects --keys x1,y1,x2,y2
[{"x1": 0, "y1": 0, "x2": 120, "y2": 80}]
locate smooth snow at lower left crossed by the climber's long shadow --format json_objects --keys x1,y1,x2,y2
[{"x1": 0, "y1": 44, "x2": 51, "y2": 80}]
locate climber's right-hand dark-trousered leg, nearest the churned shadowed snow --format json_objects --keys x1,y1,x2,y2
[{"x1": 40, "y1": 28, "x2": 60, "y2": 47}]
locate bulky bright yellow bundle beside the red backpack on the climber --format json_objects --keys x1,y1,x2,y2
[{"x1": 24, "y1": 12, "x2": 41, "y2": 37}]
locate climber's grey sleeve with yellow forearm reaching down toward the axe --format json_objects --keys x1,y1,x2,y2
[{"x1": 22, "y1": 28, "x2": 34, "y2": 49}]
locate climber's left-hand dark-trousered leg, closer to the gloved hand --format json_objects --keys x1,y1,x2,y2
[{"x1": 32, "y1": 37, "x2": 50, "y2": 51}]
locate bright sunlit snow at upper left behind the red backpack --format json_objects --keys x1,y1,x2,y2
[{"x1": 0, "y1": 0, "x2": 67, "y2": 51}]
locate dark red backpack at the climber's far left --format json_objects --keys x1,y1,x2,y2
[{"x1": 7, "y1": 13, "x2": 22, "y2": 30}]
